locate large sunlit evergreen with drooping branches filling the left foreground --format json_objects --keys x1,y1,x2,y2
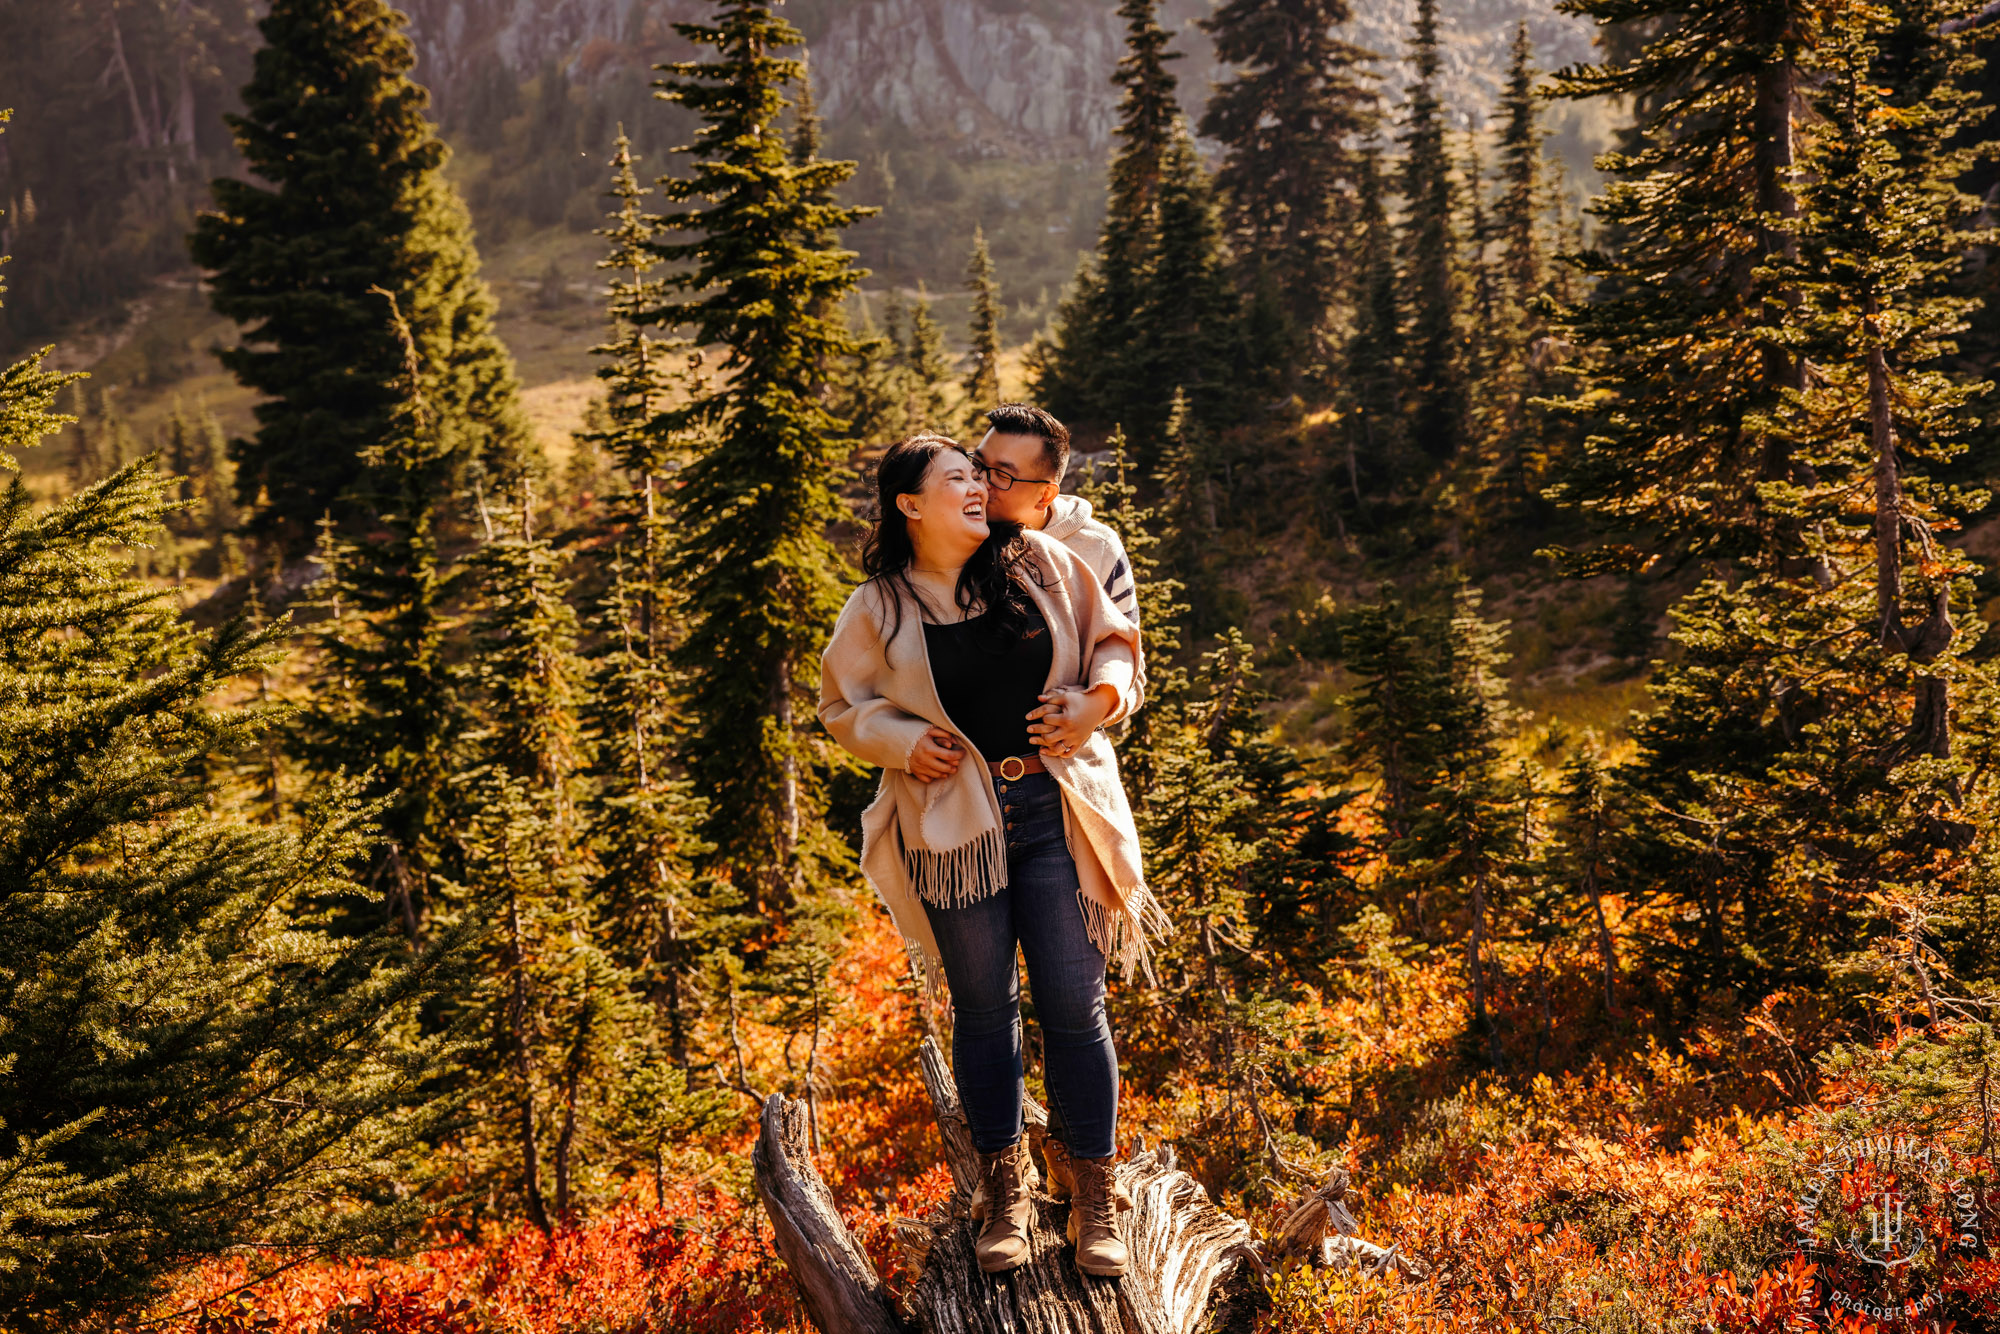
[{"x1": 0, "y1": 172, "x2": 464, "y2": 1334}]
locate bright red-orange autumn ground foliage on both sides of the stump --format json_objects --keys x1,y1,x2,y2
[{"x1": 162, "y1": 912, "x2": 2000, "y2": 1334}]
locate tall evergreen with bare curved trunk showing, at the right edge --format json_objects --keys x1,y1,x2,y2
[{"x1": 1560, "y1": 6, "x2": 1994, "y2": 1008}]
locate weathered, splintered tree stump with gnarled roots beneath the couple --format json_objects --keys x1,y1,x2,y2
[{"x1": 754, "y1": 1038, "x2": 1412, "y2": 1334}]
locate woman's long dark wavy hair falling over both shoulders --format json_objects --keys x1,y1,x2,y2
[{"x1": 862, "y1": 430, "x2": 1044, "y2": 642}]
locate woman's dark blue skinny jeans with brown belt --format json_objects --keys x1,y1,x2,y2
[{"x1": 924, "y1": 774, "x2": 1118, "y2": 1158}]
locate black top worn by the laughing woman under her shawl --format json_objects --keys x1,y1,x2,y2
[{"x1": 924, "y1": 600, "x2": 1056, "y2": 760}]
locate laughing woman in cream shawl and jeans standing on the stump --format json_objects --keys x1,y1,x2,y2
[{"x1": 820, "y1": 434, "x2": 1164, "y2": 1274}]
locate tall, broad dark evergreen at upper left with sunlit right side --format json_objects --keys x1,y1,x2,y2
[{"x1": 192, "y1": 0, "x2": 532, "y2": 552}]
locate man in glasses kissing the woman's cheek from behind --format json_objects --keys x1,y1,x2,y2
[{"x1": 974, "y1": 402, "x2": 1138, "y2": 622}]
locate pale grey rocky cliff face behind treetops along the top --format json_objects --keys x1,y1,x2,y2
[{"x1": 406, "y1": 0, "x2": 1590, "y2": 156}]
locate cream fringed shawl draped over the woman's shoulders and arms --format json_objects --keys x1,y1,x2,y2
[{"x1": 820, "y1": 532, "x2": 1166, "y2": 986}]
